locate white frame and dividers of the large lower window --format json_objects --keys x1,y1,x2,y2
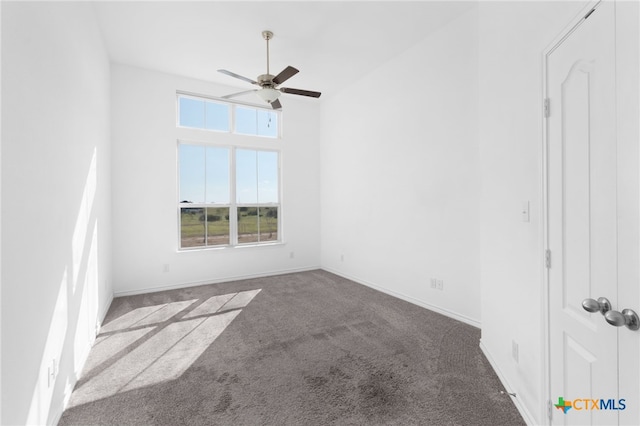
[{"x1": 176, "y1": 139, "x2": 284, "y2": 251}]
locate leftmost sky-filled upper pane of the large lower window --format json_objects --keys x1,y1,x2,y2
[{"x1": 178, "y1": 144, "x2": 205, "y2": 203}]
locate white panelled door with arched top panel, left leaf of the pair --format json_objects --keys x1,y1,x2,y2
[{"x1": 546, "y1": 1, "x2": 640, "y2": 425}]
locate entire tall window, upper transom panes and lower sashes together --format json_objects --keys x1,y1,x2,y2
[{"x1": 177, "y1": 93, "x2": 280, "y2": 249}]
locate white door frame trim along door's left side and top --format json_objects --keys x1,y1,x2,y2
[{"x1": 540, "y1": 0, "x2": 614, "y2": 425}]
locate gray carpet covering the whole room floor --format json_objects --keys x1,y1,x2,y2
[{"x1": 60, "y1": 271, "x2": 524, "y2": 425}]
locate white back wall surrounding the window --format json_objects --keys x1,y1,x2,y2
[{"x1": 111, "y1": 64, "x2": 320, "y2": 294}]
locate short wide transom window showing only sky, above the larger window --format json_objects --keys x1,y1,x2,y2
[{"x1": 178, "y1": 94, "x2": 280, "y2": 138}]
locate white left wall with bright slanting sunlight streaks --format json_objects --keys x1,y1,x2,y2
[{"x1": 0, "y1": 2, "x2": 112, "y2": 425}]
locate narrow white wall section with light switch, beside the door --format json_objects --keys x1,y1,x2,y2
[{"x1": 478, "y1": 1, "x2": 586, "y2": 424}]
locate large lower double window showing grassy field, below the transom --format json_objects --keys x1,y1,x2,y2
[{"x1": 178, "y1": 143, "x2": 280, "y2": 249}]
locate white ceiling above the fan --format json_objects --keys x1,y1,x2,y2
[{"x1": 94, "y1": 0, "x2": 477, "y2": 97}]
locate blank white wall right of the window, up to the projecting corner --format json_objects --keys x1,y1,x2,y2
[{"x1": 321, "y1": 9, "x2": 480, "y2": 326}]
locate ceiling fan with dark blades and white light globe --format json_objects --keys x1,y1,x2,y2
[{"x1": 218, "y1": 31, "x2": 321, "y2": 109}]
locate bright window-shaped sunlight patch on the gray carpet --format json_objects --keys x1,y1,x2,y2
[{"x1": 69, "y1": 289, "x2": 260, "y2": 407}]
